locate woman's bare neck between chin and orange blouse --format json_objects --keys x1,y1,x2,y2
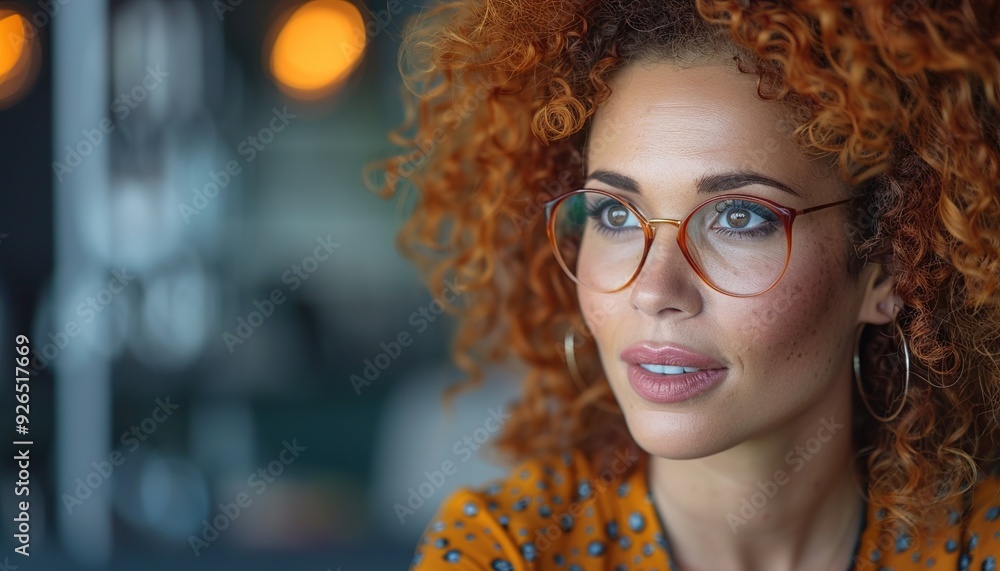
[{"x1": 649, "y1": 383, "x2": 866, "y2": 571}]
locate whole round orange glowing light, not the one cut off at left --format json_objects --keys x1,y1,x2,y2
[{"x1": 270, "y1": 0, "x2": 366, "y2": 98}]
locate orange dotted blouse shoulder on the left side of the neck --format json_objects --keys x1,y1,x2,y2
[{"x1": 411, "y1": 451, "x2": 662, "y2": 571}]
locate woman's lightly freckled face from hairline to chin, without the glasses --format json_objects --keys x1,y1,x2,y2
[{"x1": 577, "y1": 59, "x2": 869, "y2": 459}]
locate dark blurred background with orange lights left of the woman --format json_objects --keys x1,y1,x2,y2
[{"x1": 0, "y1": 0, "x2": 518, "y2": 571}]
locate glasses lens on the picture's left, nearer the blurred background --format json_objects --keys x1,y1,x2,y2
[{"x1": 552, "y1": 192, "x2": 646, "y2": 291}]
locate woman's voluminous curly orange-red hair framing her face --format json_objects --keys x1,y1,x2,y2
[{"x1": 371, "y1": 0, "x2": 1000, "y2": 530}]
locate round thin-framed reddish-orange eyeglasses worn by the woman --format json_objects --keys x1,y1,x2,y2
[{"x1": 545, "y1": 189, "x2": 850, "y2": 297}]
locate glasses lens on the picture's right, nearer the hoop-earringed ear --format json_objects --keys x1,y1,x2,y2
[{"x1": 686, "y1": 198, "x2": 788, "y2": 295}]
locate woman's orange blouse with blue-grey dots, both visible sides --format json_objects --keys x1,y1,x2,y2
[{"x1": 410, "y1": 452, "x2": 1000, "y2": 571}]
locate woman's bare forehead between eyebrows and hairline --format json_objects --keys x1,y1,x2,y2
[{"x1": 587, "y1": 62, "x2": 831, "y2": 197}]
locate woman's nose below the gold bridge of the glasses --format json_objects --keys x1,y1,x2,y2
[{"x1": 630, "y1": 219, "x2": 702, "y2": 317}]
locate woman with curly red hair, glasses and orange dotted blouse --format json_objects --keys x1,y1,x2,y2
[{"x1": 372, "y1": 0, "x2": 1000, "y2": 571}]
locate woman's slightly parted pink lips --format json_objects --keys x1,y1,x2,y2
[{"x1": 621, "y1": 343, "x2": 727, "y2": 403}]
